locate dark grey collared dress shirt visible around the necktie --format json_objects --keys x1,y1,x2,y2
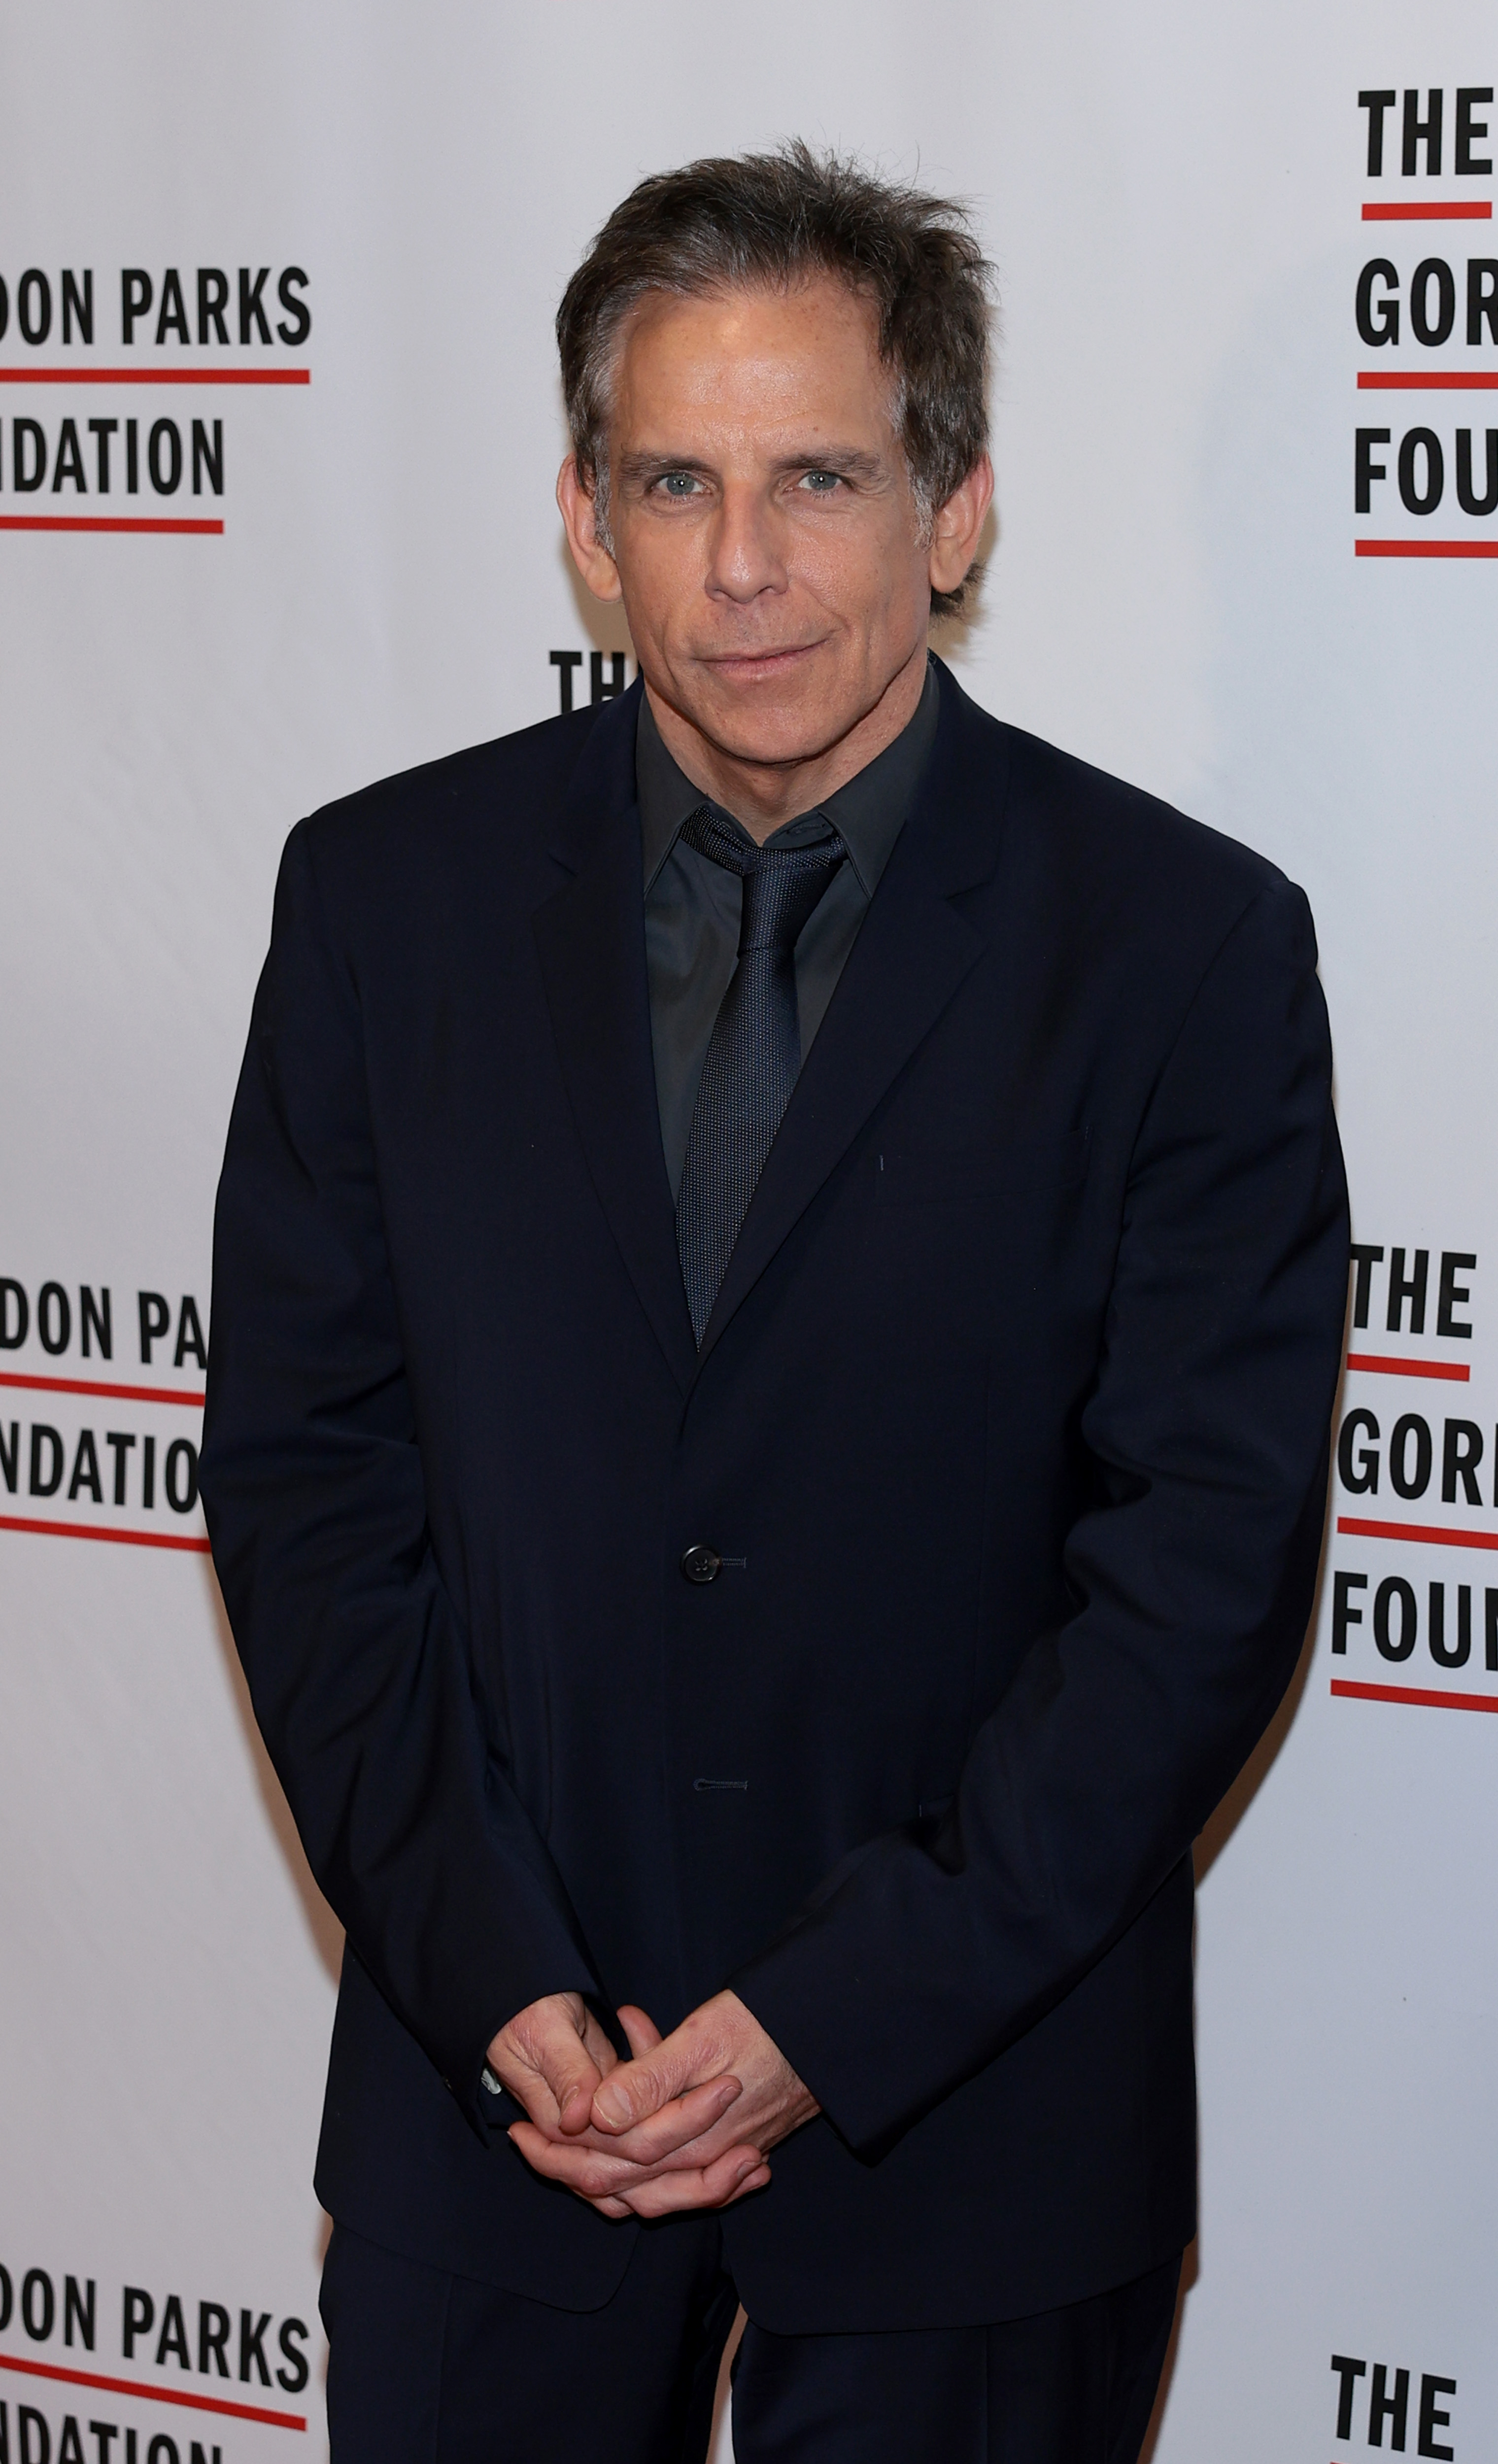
[{"x1": 636, "y1": 668, "x2": 941, "y2": 1198}]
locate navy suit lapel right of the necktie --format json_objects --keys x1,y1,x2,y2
[{"x1": 695, "y1": 663, "x2": 1008, "y2": 1363}]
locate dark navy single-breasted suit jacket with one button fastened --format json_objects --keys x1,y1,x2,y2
[{"x1": 202, "y1": 670, "x2": 1345, "y2": 2331}]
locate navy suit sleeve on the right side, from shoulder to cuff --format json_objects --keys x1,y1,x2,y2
[{"x1": 732, "y1": 882, "x2": 1348, "y2": 2154}]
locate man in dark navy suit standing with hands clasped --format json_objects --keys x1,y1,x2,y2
[{"x1": 202, "y1": 148, "x2": 1345, "y2": 2464}]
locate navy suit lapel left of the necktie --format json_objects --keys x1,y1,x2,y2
[{"x1": 535, "y1": 683, "x2": 697, "y2": 1390}]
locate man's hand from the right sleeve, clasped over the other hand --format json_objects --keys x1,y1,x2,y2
[{"x1": 510, "y1": 1993, "x2": 818, "y2": 2215}]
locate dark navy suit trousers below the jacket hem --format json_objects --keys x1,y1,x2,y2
[{"x1": 323, "y1": 2218, "x2": 1180, "y2": 2464}]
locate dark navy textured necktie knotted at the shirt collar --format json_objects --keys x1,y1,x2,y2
[{"x1": 675, "y1": 803, "x2": 848, "y2": 1343}]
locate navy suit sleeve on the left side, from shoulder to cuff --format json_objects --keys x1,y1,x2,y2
[{"x1": 202, "y1": 823, "x2": 596, "y2": 2126}]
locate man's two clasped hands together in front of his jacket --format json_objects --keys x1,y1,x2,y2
[{"x1": 488, "y1": 1993, "x2": 818, "y2": 2215}]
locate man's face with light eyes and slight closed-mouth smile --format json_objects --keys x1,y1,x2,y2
[{"x1": 577, "y1": 278, "x2": 931, "y2": 764}]
